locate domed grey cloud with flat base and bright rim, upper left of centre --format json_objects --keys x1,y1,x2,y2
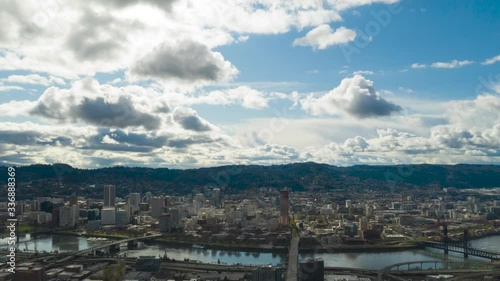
[{"x1": 129, "y1": 41, "x2": 238, "y2": 85}]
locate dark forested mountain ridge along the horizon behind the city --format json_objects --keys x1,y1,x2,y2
[{"x1": 0, "y1": 162, "x2": 500, "y2": 197}]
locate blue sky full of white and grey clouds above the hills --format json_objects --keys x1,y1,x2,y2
[{"x1": 0, "y1": 0, "x2": 500, "y2": 166}]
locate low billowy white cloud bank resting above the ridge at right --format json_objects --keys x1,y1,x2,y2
[{"x1": 310, "y1": 121, "x2": 500, "y2": 164}]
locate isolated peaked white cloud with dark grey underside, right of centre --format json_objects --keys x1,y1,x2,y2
[{"x1": 301, "y1": 75, "x2": 402, "y2": 118}]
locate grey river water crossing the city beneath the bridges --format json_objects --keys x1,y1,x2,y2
[{"x1": 0, "y1": 235, "x2": 500, "y2": 269}]
